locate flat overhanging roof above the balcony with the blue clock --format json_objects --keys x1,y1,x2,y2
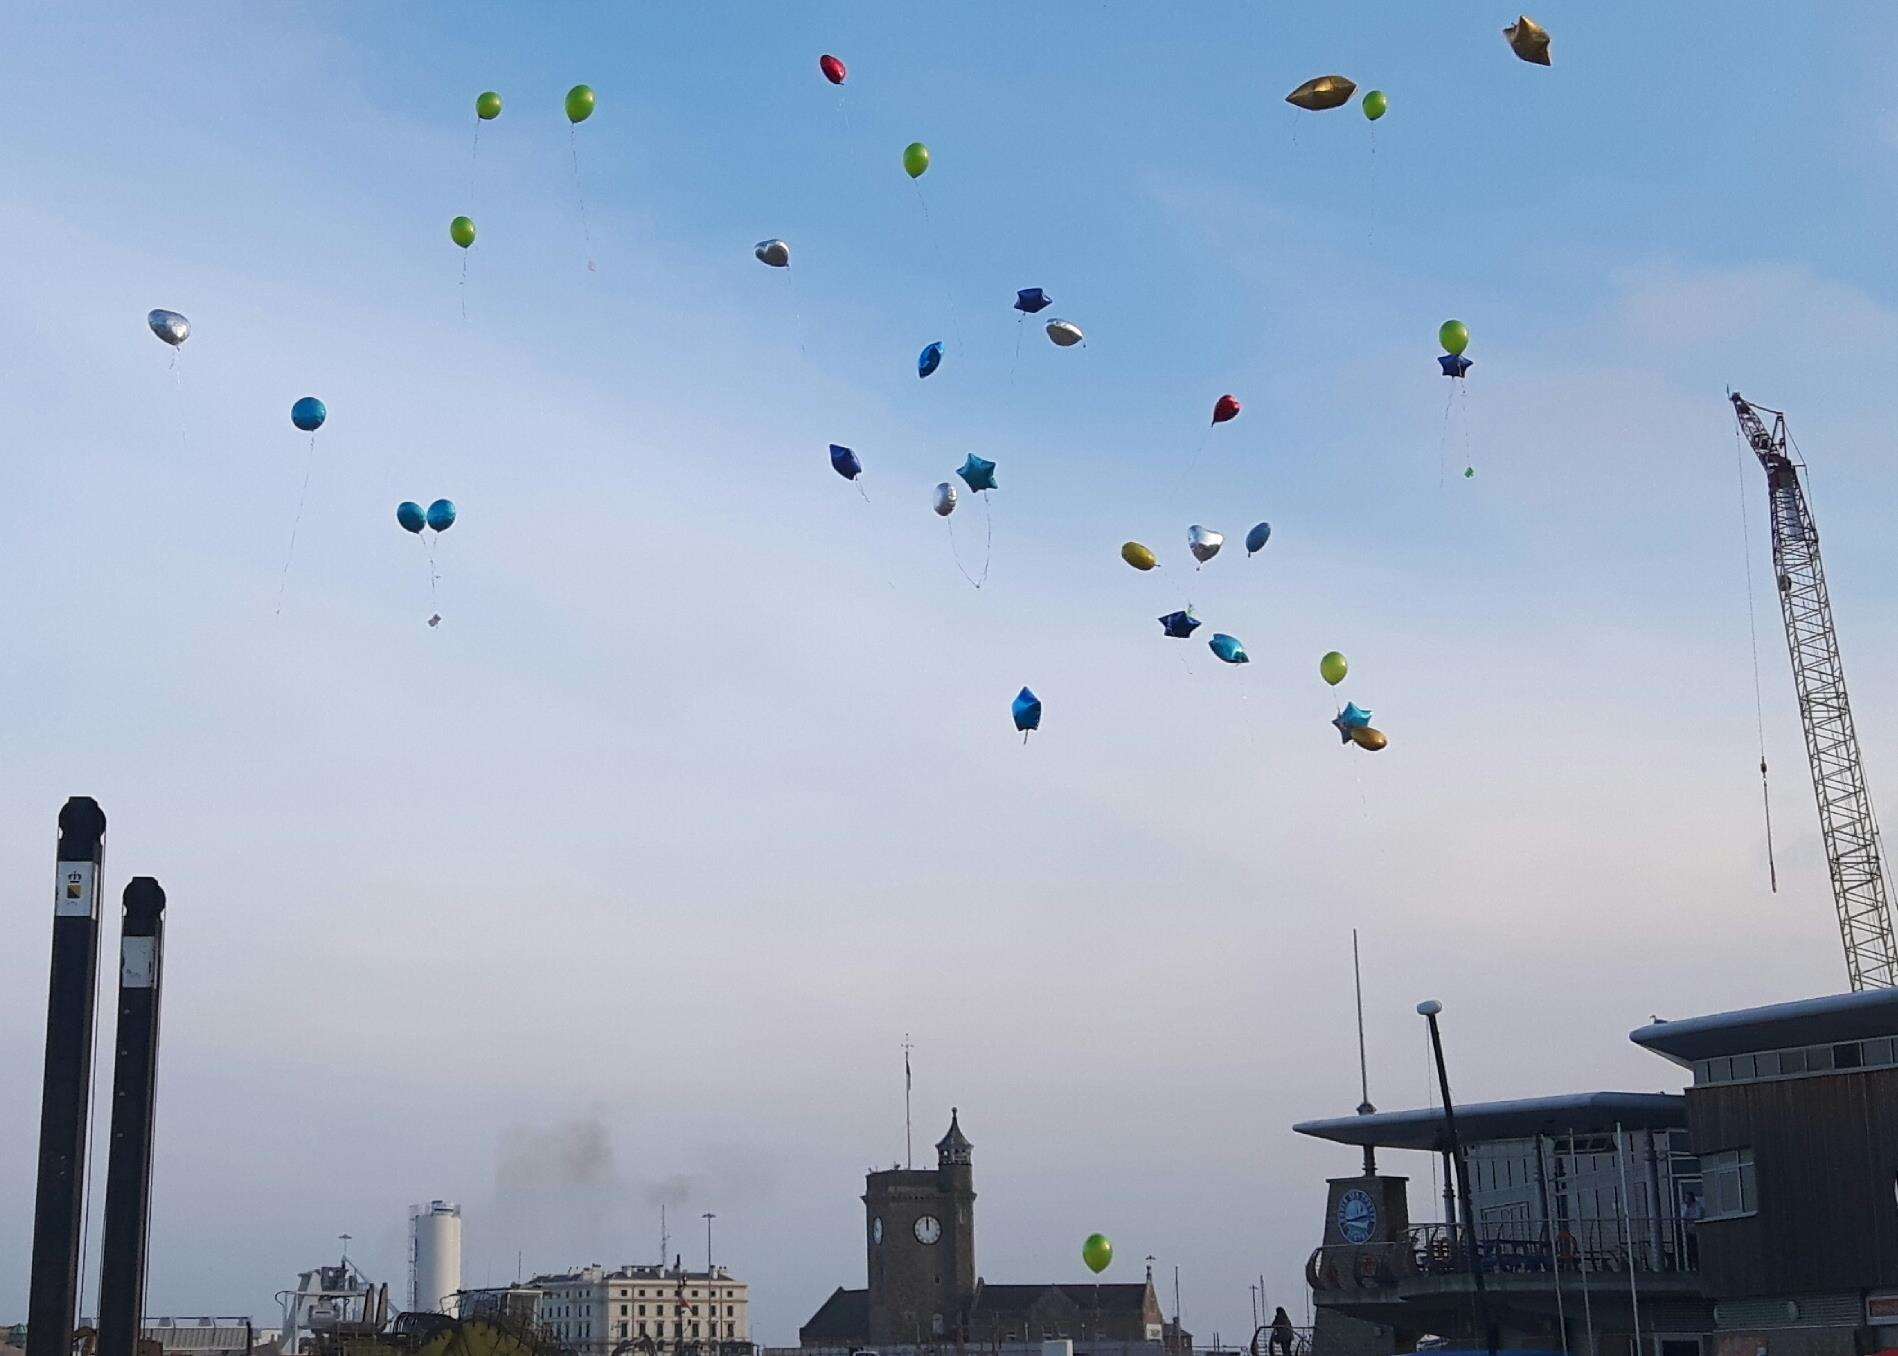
[{"x1": 1293, "y1": 1092, "x2": 1687, "y2": 1153}]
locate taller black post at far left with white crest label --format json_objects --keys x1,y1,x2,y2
[{"x1": 27, "y1": 796, "x2": 106, "y2": 1356}]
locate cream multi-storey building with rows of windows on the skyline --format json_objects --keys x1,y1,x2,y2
[{"x1": 531, "y1": 1261, "x2": 752, "y2": 1356}]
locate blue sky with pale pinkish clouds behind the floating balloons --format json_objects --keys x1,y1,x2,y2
[{"x1": 0, "y1": 0, "x2": 1898, "y2": 1343}]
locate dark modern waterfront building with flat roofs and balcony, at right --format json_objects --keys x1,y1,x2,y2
[{"x1": 1294, "y1": 989, "x2": 1898, "y2": 1356}]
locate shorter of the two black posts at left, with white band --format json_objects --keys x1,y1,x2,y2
[{"x1": 99, "y1": 876, "x2": 165, "y2": 1356}]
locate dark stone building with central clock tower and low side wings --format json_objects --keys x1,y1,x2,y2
[{"x1": 797, "y1": 1111, "x2": 1163, "y2": 1350}]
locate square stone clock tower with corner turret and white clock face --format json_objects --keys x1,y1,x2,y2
[{"x1": 864, "y1": 1109, "x2": 976, "y2": 1345}]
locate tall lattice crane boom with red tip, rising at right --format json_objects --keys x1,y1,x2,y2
[{"x1": 1729, "y1": 393, "x2": 1898, "y2": 989}]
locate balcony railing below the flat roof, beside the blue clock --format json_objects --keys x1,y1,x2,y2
[{"x1": 1306, "y1": 1217, "x2": 1699, "y2": 1291}]
